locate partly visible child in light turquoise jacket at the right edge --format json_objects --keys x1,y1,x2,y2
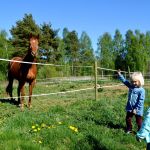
[{"x1": 136, "y1": 108, "x2": 150, "y2": 150}]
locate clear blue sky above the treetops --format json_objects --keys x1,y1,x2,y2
[{"x1": 0, "y1": 0, "x2": 150, "y2": 51}]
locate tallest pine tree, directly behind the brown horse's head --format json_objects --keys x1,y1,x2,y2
[{"x1": 10, "y1": 14, "x2": 40, "y2": 56}]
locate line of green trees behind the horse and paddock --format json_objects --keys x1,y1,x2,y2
[{"x1": 0, "y1": 14, "x2": 150, "y2": 78}]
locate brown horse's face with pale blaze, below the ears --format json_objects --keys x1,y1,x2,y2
[{"x1": 30, "y1": 37, "x2": 39, "y2": 56}]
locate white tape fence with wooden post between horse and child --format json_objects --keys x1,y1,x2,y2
[{"x1": 0, "y1": 58, "x2": 128, "y2": 100}]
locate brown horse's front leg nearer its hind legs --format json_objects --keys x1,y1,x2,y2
[{"x1": 18, "y1": 82, "x2": 25, "y2": 110}]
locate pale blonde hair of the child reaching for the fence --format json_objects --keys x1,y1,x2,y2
[{"x1": 130, "y1": 72, "x2": 144, "y2": 86}]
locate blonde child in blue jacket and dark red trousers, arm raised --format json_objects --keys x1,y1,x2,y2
[{"x1": 118, "y1": 70, "x2": 145, "y2": 134}]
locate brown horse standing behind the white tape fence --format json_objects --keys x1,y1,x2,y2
[{"x1": 6, "y1": 36, "x2": 39, "y2": 110}]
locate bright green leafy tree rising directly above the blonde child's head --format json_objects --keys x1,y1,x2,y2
[{"x1": 126, "y1": 30, "x2": 147, "y2": 72}]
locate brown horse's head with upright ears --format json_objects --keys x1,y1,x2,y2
[{"x1": 30, "y1": 36, "x2": 39, "y2": 57}]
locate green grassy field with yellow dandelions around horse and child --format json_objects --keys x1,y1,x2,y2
[{"x1": 0, "y1": 81, "x2": 150, "y2": 150}]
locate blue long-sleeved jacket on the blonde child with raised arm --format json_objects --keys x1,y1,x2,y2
[{"x1": 119, "y1": 75, "x2": 145, "y2": 116}]
